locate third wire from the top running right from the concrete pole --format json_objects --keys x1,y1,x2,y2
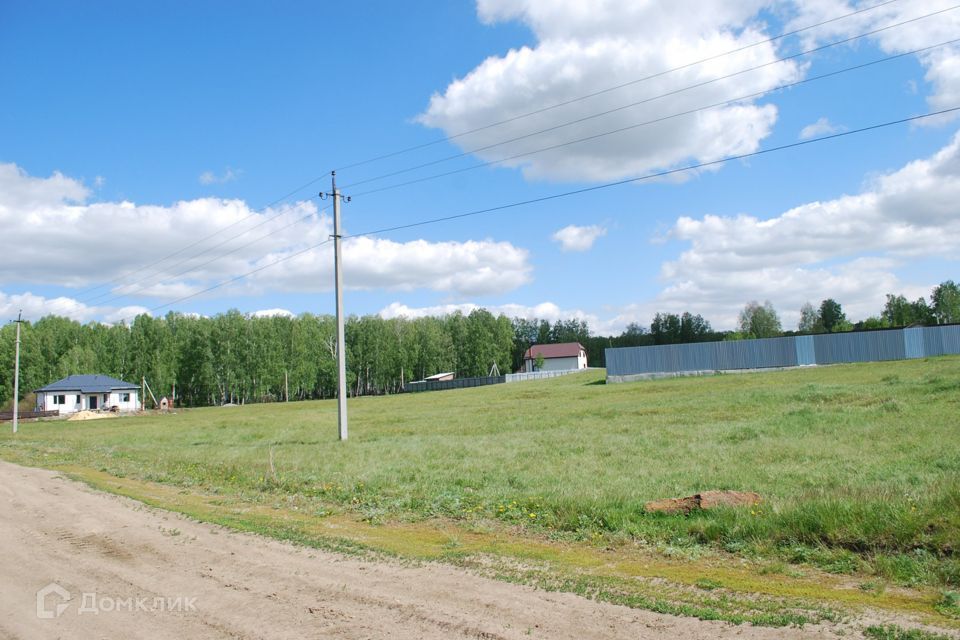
[{"x1": 351, "y1": 38, "x2": 960, "y2": 198}]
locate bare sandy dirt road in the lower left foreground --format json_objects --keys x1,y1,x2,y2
[{"x1": 0, "y1": 462, "x2": 849, "y2": 640}]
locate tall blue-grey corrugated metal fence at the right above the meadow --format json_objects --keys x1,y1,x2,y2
[{"x1": 606, "y1": 325, "x2": 960, "y2": 377}]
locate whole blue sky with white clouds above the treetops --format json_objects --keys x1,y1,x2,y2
[{"x1": 0, "y1": 0, "x2": 960, "y2": 333}]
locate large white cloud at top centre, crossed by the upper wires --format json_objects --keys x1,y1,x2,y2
[{"x1": 420, "y1": 0, "x2": 803, "y2": 181}]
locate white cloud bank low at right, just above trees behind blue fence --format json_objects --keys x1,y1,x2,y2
[{"x1": 657, "y1": 134, "x2": 960, "y2": 328}]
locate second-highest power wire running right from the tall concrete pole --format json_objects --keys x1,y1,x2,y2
[{"x1": 343, "y1": 4, "x2": 960, "y2": 195}]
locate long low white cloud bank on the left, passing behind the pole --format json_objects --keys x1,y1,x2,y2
[{"x1": 0, "y1": 164, "x2": 532, "y2": 313}]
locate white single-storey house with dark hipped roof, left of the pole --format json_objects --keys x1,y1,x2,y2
[{"x1": 36, "y1": 374, "x2": 140, "y2": 415}]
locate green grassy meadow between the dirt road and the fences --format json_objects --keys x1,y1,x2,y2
[{"x1": 0, "y1": 357, "x2": 960, "y2": 618}]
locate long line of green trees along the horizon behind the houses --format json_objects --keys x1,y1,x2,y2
[{"x1": 0, "y1": 280, "x2": 960, "y2": 407}]
